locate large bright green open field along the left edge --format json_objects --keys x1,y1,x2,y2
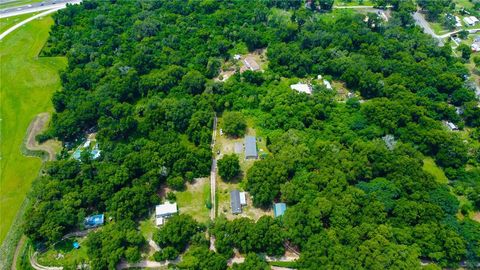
[{"x1": 0, "y1": 14, "x2": 66, "y2": 242}]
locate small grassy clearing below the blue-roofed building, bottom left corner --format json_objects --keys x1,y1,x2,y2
[{"x1": 37, "y1": 237, "x2": 88, "y2": 269}]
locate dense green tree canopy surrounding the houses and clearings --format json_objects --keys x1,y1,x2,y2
[{"x1": 24, "y1": 0, "x2": 480, "y2": 269}]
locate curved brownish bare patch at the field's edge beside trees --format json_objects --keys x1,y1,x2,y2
[{"x1": 25, "y1": 113, "x2": 61, "y2": 160}]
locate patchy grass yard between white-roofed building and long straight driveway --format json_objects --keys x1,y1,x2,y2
[{"x1": 175, "y1": 177, "x2": 210, "y2": 223}]
